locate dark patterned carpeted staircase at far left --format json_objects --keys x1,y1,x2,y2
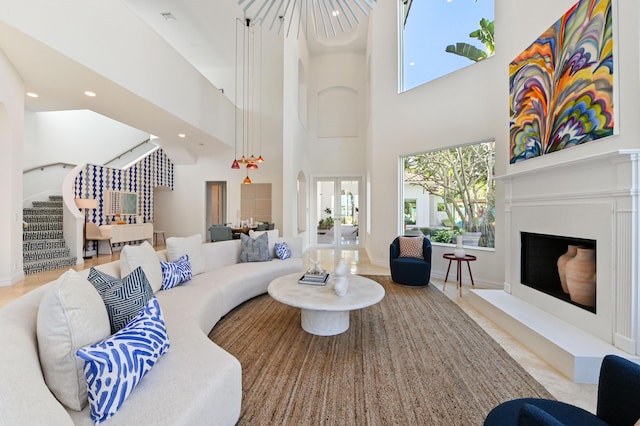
[{"x1": 22, "y1": 195, "x2": 76, "y2": 275}]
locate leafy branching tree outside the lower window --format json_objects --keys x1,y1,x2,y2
[{"x1": 405, "y1": 142, "x2": 495, "y2": 246}]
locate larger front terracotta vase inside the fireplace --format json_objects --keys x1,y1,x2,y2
[{"x1": 565, "y1": 247, "x2": 596, "y2": 307}]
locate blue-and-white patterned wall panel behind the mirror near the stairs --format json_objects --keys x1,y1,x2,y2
[{"x1": 73, "y1": 149, "x2": 174, "y2": 225}]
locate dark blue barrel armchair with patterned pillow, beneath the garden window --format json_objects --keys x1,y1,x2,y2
[{"x1": 389, "y1": 237, "x2": 431, "y2": 286}]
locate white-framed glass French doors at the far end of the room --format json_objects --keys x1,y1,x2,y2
[{"x1": 314, "y1": 178, "x2": 361, "y2": 247}]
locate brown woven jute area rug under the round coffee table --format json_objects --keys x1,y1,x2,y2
[{"x1": 209, "y1": 276, "x2": 552, "y2": 425}]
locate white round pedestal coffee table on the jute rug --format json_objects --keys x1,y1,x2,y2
[{"x1": 268, "y1": 273, "x2": 384, "y2": 336}]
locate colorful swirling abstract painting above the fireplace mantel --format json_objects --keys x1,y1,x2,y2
[{"x1": 509, "y1": 0, "x2": 614, "y2": 164}]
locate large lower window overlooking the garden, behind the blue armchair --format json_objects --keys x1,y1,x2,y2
[{"x1": 403, "y1": 141, "x2": 495, "y2": 247}]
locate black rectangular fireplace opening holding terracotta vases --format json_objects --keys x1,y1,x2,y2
[{"x1": 520, "y1": 232, "x2": 596, "y2": 313}]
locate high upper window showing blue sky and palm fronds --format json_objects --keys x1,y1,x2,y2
[{"x1": 398, "y1": 0, "x2": 494, "y2": 92}]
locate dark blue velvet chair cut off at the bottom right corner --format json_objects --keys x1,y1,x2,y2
[{"x1": 484, "y1": 355, "x2": 640, "y2": 426}]
